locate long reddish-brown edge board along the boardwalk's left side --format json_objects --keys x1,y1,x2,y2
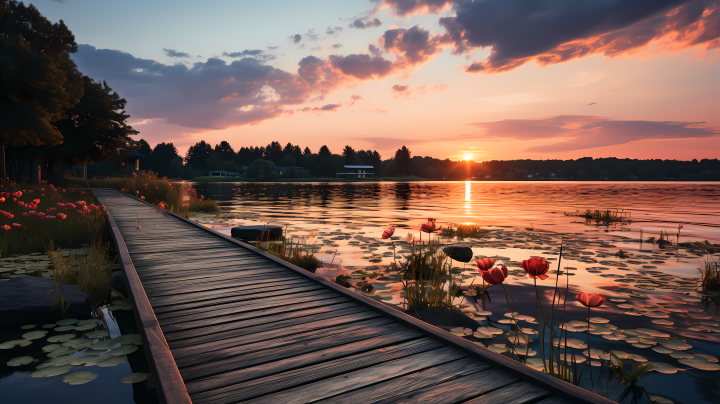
[{"x1": 100, "y1": 193, "x2": 191, "y2": 404}]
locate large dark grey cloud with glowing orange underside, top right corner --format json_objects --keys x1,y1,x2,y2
[{"x1": 440, "y1": 0, "x2": 720, "y2": 73}]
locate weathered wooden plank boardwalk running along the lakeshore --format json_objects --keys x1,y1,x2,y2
[{"x1": 94, "y1": 190, "x2": 611, "y2": 404}]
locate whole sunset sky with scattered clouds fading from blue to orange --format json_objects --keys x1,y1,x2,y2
[{"x1": 35, "y1": 0, "x2": 720, "y2": 161}]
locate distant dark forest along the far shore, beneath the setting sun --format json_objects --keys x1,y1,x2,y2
[{"x1": 109, "y1": 140, "x2": 720, "y2": 181}]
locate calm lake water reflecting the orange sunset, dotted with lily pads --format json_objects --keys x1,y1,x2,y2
[{"x1": 194, "y1": 182, "x2": 720, "y2": 403}]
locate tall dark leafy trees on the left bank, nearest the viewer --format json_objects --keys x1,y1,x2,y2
[{"x1": 0, "y1": 0, "x2": 138, "y2": 182}]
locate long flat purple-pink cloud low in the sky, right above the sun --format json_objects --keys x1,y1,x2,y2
[{"x1": 472, "y1": 115, "x2": 720, "y2": 153}]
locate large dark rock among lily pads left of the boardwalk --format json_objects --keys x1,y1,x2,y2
[{"x1": 0, "y1": 276, "x2": 92, "y2": 325}]
